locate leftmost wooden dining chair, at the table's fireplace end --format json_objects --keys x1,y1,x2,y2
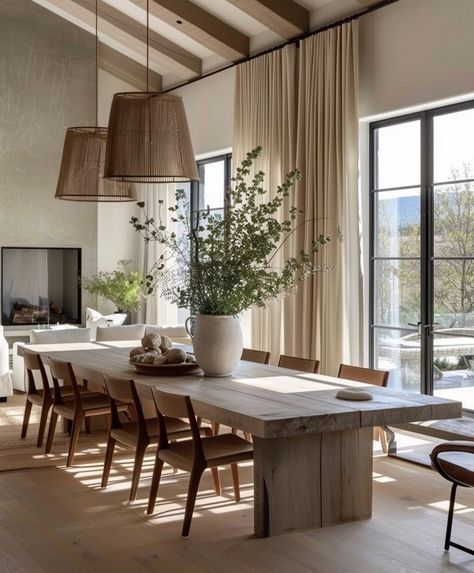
[{"x1": 21, "y1": 348, "x2": 53, "y2": 448}]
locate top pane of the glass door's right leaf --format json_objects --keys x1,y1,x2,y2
[{"x1": 433, "y1": 109, "x2": 474, "y2": 182}]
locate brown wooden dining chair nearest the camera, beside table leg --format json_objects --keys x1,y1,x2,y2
[{"x1": 147, "y1": 388, "x2": 253, "y2": 537}]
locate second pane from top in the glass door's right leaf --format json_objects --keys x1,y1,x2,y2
[{"x1": 433, "y1": 183, "x2": 474, "y2": 257}]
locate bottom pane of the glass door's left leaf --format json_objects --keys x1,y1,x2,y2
[{"x1": 374, "y1": 328, "x2": 420, "y2": 392}]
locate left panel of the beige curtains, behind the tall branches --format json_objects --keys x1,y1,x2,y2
[{"x1": 232, "y1": 44, "x2": 297, "y2": 355}]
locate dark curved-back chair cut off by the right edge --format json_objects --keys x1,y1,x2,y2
[{"x1": 430, "y1": 441, "x2": 474, "y2": 555}]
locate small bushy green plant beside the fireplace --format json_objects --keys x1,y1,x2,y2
[{"x1": 82, "y1": 259, "x2": 146, "y2": 312}]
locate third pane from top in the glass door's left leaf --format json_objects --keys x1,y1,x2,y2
[{"x1": 374, "y1": 260, "x2": 420, "y2": 327}]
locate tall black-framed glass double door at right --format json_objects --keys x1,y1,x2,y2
[{"x1": 369, "y1": 102, "x2": 474, "y2": 410}]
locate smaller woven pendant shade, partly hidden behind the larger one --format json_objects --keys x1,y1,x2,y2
[{"x1": 55, "y1": 127, "x2": 136, "y2": 201}]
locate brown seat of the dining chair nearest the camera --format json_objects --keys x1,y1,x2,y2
[{"x1": 160, "y1": 434, "x2": 253, "y2": 469}]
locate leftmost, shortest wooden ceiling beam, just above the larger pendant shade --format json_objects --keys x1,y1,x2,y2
[{"x1": 99, "y1": 42, "x2": 163, "y2": 92}]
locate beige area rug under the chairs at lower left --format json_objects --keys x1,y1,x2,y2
[{"x1": 0, "y1": 394, "x2": 154, "y2": 471}]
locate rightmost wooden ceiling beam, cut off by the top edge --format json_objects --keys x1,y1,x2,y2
[{"x1": 227, "y1": 0, "x2": 309, "y2": 40}]
